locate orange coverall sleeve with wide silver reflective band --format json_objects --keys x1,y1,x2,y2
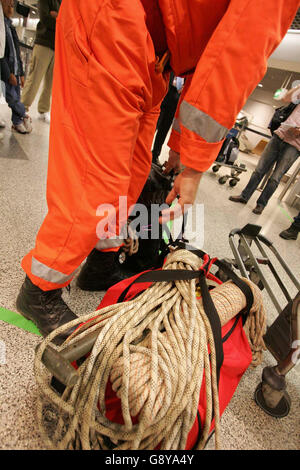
[{"x1": 169, "y1": 0, "x2": 300, "y2": 171}]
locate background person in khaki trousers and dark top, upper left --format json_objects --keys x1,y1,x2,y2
[{"x1": 22, "y1": 0, "x2": 62, "y2": 123}]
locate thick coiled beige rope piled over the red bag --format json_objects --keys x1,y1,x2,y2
[{"x1": 34, "y1": 250, "x2": 265, "y2": 450}]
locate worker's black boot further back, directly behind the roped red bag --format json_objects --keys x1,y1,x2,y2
[{"x1": 77, "y1": 249, "x2": 133, "y2": 291}]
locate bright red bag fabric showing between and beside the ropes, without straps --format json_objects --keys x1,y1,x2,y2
[{"x1": 98, "y1": 273, "x2": 252, "y2": 449}]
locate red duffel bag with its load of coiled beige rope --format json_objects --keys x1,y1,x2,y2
[{"x1": 35, "y1": 248, "x2": 262, "y2": 450}]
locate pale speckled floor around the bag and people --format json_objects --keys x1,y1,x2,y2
[{"x1": 0, "y1": 104, "x2": 300, "y2": 450}]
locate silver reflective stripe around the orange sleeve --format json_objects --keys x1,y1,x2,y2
[{"x1": 179, "y1": 101, "x2": 229, "y2": 143}]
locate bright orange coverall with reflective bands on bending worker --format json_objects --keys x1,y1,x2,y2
[{"x1": 22, "y1": 0, "x2": 300, "y2": 290}]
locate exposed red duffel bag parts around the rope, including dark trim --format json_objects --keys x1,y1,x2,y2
[{"x1": 98, "y1": 250, "x2": 253, "y2": 449}]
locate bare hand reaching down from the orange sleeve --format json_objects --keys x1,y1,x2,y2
[{"x1": 159, "y1": 167, "x2": 203, "y2": 223}]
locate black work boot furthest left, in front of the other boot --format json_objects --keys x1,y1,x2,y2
[{"x1": 17, "y1": 276, "x2": 77, "y2": 345}]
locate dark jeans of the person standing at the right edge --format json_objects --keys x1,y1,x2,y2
[{"x1": 241, "y1": 134, "x2": 300, "y2": 207}]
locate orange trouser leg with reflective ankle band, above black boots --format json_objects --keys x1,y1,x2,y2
[{"x1": 22, "y1": 0, "x2": 166, "y2": 290}]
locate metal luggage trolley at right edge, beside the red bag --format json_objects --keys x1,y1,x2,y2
[{"x1": 218, "y1": 224, "x2": 300, "y2": 418}]
